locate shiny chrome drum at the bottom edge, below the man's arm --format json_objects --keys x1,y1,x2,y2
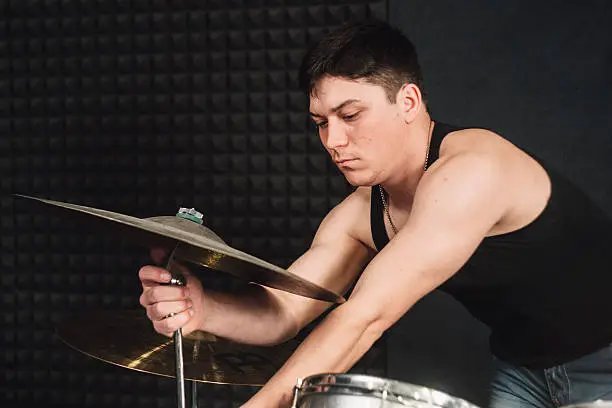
[{"x1": 292, "y1": 374, "x2": 478, "y2": 408}]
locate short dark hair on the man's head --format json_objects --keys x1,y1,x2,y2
[{"x1": 299, "y1": 21, "x2": 423, "y2": 103}]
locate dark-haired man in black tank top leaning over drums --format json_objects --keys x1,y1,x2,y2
[{"x1": 140, "y1": 22, "x2": 612, "y2": 408}]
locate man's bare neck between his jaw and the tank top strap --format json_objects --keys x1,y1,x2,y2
[{"x1": 381, "y1": 114, "x2": 434, "y2": 206}]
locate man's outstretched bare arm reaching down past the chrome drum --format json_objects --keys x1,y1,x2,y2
[{"x1": 245, "y1": 154, "x2": 507, "y2": 408}]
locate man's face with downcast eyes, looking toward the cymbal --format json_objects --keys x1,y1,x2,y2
[{"x1": 310, "y1": 77, "x2": 406, "y2": 186}]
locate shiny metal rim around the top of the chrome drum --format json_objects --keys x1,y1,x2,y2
[{"x1": 299, "y1": 373, "x2": 479, "y2": 408}]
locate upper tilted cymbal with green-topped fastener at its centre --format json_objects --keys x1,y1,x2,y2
[{"x1": 16, "y1": 194, "x2": 345, "y2": 303}]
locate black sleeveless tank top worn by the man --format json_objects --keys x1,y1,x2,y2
[{"x1": 370, "y1": 123, "x2": 612, "y2": 368}]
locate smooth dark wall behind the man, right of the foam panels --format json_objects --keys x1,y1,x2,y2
[{"x1": 387, "y1": 0, "x2": 612, "y2": 406}]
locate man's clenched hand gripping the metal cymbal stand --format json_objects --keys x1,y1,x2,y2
[{"x1": 138, "y1": 249, "x2": 204, "y2": 336}]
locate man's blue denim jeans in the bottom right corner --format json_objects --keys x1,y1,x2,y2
[{"x1": 489, "y1": 345, "x2": 612, "y2": 408}]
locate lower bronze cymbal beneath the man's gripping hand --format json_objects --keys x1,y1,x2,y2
[{"x1": 56, "y1": 309, "x2": 299, "y2": 386}]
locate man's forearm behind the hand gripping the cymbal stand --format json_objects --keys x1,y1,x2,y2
[{"x1": 200, "y1": 285, "x2": 298, "y2": 346}]
